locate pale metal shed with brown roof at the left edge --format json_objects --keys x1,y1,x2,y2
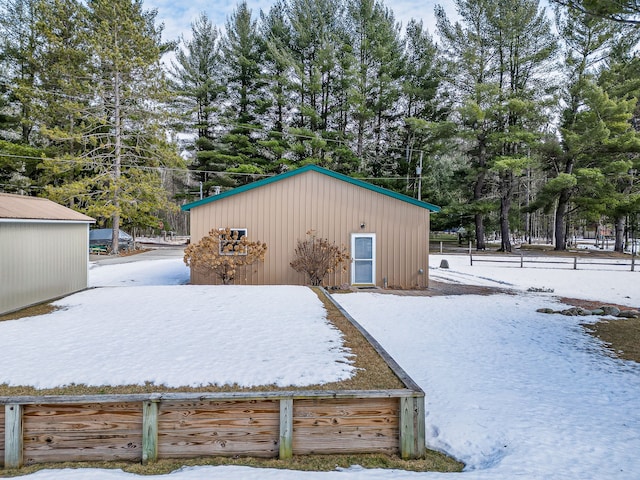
[{"x1": 0, "y1": 193, "x2": 95, "y2": 314}]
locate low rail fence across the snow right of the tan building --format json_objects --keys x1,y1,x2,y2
[{"x1": 469, "y1": 254, "x2": 636, "y2": 272}]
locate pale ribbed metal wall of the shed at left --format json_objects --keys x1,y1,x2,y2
[{"x1": 0, "y1": 222, "x2": 89, "y2": 314}]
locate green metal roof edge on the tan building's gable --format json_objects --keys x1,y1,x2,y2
[{"x1": 182, "y1": 165, "x2": 440, "y2": 213}]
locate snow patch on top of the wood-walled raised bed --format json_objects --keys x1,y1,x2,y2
[{"x1": 0, "y1": 284, "x2": 353, "y2": 388}]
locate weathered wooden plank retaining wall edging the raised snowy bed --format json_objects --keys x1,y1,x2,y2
[{"x1": 0, "y1": 288, "x2": 425, "y2": 468}]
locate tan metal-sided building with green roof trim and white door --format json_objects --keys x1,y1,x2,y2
[{"x1": 182, "y1": 165, "x2": 440, "y2": 289}]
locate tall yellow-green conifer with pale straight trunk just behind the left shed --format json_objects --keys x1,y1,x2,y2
[{"x1": 42, "y1": 0, "x2": 177, "y2": 253}]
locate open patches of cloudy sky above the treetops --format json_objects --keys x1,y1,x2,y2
[{"x1": 144, "y1": 0, "x2": 455, "y2": 40}]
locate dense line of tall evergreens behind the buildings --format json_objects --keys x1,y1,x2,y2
[{"x1": 0, "y1": 0, "x2": 640, "y2": 251}]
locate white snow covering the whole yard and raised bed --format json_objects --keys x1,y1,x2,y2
[{"x1": 5, "y1": 254, "x2": 640, "y2": 480}]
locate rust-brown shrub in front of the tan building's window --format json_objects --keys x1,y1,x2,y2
[{"x1": 184, "y1": 227, "x2": 267, "y2": 285}]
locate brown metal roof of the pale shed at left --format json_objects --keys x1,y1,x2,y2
[{"x1": 0, "y1": 193, "x2": 95, "y2": 223}]
